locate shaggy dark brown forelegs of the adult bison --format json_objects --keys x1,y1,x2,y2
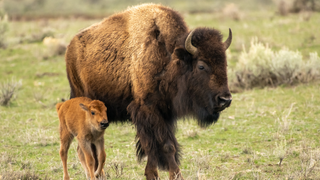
[{"x1": 127, "y1": 102, "x2": 182, "y2": 180}]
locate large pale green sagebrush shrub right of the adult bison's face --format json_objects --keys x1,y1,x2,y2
[{"x1": 230, "y1": 39, "x2": 320, "y2": 89}]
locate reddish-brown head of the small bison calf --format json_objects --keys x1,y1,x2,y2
[{"x1": 80, "y1": 100, "x2": 109, "y2": 130}]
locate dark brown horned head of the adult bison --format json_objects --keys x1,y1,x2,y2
[{"x1": 173, "y1": 28, "x2": 232, "y2": 126}]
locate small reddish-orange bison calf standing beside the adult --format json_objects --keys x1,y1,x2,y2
[{"x1": 56, "y1": 97, "x2": 109, "y2": 180}]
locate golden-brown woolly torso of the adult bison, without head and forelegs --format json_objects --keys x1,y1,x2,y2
[{"x1": 66, "y1": 4, "x2": 188, "y2": 121}]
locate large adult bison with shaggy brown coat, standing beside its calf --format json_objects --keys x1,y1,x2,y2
[{"x1": 66, "y1": 4, "x2": 232, "y2": 180}]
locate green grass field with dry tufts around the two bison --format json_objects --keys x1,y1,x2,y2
[{"x1": 0, "y1": 2, "x2": 320, "y2": 180}]
